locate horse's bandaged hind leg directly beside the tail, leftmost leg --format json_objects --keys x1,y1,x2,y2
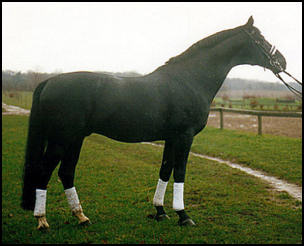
[{"x1": 34, "y1": 142, "x2": 63, "y2": 230}]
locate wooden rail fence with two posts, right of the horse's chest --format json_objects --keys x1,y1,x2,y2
[{"x1": 210, "y1": 107, "x2": 302, "y2": 135}]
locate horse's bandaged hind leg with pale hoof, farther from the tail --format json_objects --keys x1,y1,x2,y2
[{"x1": 58, "y1": 138, "x2": 90, "y2": 224}]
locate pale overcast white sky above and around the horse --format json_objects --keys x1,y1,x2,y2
[{"x1": 2, "y1": 2, "x2": 302, "y2": 82}]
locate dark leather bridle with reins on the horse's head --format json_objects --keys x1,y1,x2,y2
[{"x1": 242, "y1": 29, "x2": 302, "y2": 99}]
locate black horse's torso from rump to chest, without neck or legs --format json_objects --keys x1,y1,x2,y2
[{"x1": 35, "y1": 69, "x2": 206, "y2": 142}]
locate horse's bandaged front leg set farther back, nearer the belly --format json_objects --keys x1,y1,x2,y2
[{"x1": 153, "y1": 140, "x2": 174, "y2": 221}]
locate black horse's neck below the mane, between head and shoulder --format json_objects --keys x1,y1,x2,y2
[{"x1": 158, "y1": 34, "x2": 240, "y2": 103}]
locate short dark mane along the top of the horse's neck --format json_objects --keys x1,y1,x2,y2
[{"x1": 166, "y1": 27, "x2": 242, "y2": 64}]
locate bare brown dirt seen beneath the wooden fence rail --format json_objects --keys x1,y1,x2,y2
[{"x1": 207, "y1": 112, "x2": 302, "y2": 138}]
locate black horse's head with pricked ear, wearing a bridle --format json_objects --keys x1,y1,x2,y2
[{"x1": 242, "y1": 16, "x2": 286, "y2": 74}]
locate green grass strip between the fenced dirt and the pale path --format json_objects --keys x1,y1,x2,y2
[{"x1": 191, "y1": 127, "x2": 302, "y2": 186}]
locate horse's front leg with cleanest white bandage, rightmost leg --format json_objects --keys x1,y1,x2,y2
[{"x1": 173, "y1": 134, "x2": 195, "y2": 226}]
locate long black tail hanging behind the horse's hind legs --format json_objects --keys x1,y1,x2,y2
[{"x1": 21, "y1": 81, "x2": 47, "y2": 210}]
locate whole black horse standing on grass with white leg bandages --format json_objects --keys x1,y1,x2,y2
[{"x1": 22, "y1": 17, "x2": 286, "y2": 228}]
